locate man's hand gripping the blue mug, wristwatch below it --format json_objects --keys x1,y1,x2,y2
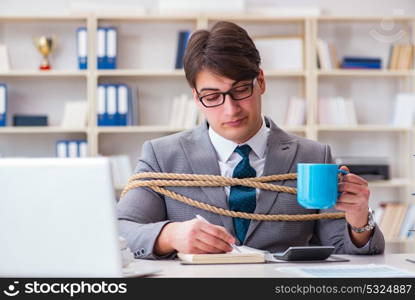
[{"x1": 335, "y1": 166, "x2": 371, "y2": 247}]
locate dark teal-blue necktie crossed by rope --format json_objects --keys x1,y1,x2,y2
[{"x1": 229, "y1": 145, "x2": 256, "y2": 244}]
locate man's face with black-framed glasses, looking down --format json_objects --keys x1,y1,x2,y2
[{"x1": 193, "y1": 70, "x2": 265, "y2": 144}]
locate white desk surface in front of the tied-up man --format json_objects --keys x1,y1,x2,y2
[{"x1": 133, "y1": 253, "x2": 415, "y2": 278}]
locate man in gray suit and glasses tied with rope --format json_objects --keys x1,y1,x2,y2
[{"x1": 118, "y1": 22, "x2": 384, "y2": 258}]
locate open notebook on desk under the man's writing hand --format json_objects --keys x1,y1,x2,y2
[{"x1": 178, "y1": 246, "x2": 267, "y2": 264}]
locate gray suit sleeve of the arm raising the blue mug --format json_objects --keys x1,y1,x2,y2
[{"x1": 313, "y1": 145, "x2": 385, "y2": 254}]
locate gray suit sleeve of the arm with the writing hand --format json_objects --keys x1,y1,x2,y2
[{"x1": 117, "y1": 141, "x2": 176, "y2": 259}]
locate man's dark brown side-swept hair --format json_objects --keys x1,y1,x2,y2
[{"x1": 183, "y1": 21, "x2": 261, "y2": 88}]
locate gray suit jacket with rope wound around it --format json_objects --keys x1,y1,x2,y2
[{"x1": 117, "y1": 118, "x2": 385, "y2": 258}]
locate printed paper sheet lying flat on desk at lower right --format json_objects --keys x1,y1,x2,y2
[{"x1": 276, "y1": 264, "x2": 415, "y2": 278}]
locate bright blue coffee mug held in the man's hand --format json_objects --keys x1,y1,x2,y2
[{"x1": 297, "y1": 164, "x2": 349, "y2": 209}]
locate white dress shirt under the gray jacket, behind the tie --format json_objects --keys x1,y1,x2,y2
[{"x1": 209, "y1": 116, "x2": 270, "y2": 200}]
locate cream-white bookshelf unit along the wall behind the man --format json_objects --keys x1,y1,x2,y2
[{"x1": 0, "y1": 15, "x2": 415, "y2": 251}]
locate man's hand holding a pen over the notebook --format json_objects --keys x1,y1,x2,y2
[{"x1": 154, "y1": 219, "x2": 235, "y2": 256}]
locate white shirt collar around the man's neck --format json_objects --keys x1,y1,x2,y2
[{"x1": 209, "y1": 116, "x2": 270, "y2": 162}]
